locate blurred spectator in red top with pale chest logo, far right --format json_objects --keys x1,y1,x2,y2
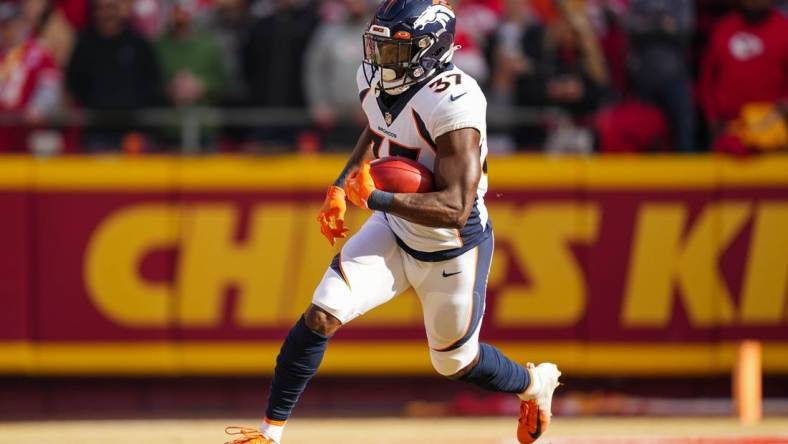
[{"x1": 700, "y1": 0, "x2": 788, "y2": 151}]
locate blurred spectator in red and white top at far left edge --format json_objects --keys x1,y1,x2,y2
[{"x1": 0, "y1": 0, "x2": 62, "y2": 152}]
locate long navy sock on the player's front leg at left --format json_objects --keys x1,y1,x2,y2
[{"x1": 265, "y1": 316, "x2": 329, "y2": 421}]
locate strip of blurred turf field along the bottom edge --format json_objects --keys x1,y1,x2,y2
[{"x1": 0, "y1": 417, "x2": 788, "y2": 444}]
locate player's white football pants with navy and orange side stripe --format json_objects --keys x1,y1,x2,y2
[{"x1": 312, "y1": 212, "x2": 494, "y2": 376}]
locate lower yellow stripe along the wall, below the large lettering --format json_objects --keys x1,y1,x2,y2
[{"x1": 0, "y1": 341, "x2": 788, "y2": 376}]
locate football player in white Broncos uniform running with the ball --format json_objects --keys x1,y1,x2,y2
[{"x1": 229, "y1": 0, "x2": 561, "y2": 444}]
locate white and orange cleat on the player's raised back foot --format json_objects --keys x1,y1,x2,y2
[{"x1": 517, "y1": 362, "x2": 561, "y2": 444}]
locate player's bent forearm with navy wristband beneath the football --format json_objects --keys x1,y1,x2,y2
[{"x1": 368, "y1": 190, "x2": 473, "y2": 229}]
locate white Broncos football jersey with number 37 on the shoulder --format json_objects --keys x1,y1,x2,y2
[{"x1": 357, "y1": 65, "x2": 491, "y2": 261}]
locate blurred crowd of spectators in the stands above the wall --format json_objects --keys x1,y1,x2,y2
[{"x1": 0, "y1": 0, "x2": 788, "y2": 155}]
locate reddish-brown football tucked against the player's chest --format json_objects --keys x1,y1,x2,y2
[{"x1": 369, "y1": 156, "x2": 433, "y2": 193}]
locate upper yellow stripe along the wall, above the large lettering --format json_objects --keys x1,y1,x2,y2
[{"x1": 0, "y1": 155, "x2": 788, "y2": 191}]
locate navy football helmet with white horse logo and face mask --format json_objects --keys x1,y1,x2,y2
[{"x1": 364, "y1": 0, "x2": 457, "y2": 95}]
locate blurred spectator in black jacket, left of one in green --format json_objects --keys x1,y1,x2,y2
[{"x1": 66, "y1": 0, "x2": 164, "y2": 151}]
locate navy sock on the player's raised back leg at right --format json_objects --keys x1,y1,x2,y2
[{"x1": 460, "y1": 343, "x2": 531, "y2": 393}]
